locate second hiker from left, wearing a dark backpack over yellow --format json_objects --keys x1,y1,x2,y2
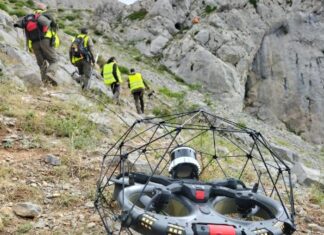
[{"x1": 69, "y1": 27, "x2": 95, "y2": 90}]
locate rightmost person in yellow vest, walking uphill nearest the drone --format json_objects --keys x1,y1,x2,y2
[{"x1": 128, "y1": 68, "x2": 150, "y2": 114}]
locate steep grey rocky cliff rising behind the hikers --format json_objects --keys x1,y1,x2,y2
[{"x1": 95, "y1": 0, "x2": 324, "y2": 144}]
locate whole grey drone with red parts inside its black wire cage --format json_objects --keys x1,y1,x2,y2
[{"x1": 95, "y1": 110, "x2": 296, "y2": 235}]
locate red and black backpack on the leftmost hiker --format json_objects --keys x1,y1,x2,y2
[{"x1": 23, "y1": 14, "x2": 48, "y2": 42}]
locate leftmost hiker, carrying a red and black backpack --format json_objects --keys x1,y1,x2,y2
[{"x1": 14, "y1": 3, "x2": 60, "y2": 85}]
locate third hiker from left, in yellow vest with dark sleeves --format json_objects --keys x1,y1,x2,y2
[{"x1": 101, "y1": 57, "x2": 123, "y2": 104}]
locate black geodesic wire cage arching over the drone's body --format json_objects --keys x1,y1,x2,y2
[{"x1": 95, "y1": 110, "x2": 295, "y2": 234}]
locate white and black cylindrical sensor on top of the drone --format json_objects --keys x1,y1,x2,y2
[{"x1": 169, "y1": 147, "x2": 201, "y2": 179}]
